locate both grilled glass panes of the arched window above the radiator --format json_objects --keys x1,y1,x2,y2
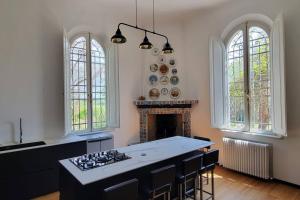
[{"x1": 225, "y1": 22, "x2": 272, "y2": 132}]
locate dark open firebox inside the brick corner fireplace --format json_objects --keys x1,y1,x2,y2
[{"x1": 148, "y1": 114, "x2": 183, "y2": 141}]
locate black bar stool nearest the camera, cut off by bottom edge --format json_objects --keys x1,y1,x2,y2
[{"x1": 103, "y1": 179, "x2": 138, "y2": 200}]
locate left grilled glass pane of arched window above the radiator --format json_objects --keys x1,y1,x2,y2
[{"x1": 227, "y1": 31, "x2": 245, "y2": 129}]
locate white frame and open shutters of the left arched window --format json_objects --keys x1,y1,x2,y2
[{"x1": 64, "y1": 30, "x2": 120, "y2": 135}]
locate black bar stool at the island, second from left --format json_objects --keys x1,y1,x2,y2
[{"x1": 144, "y1": 165, "x2": 176, "y2": 200}]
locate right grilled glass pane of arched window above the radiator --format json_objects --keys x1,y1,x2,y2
[{"x1": 249, "y1": 27, "x2": 272, "y2": 132}]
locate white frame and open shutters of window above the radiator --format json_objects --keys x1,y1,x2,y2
[{"x1": 210, "y1": 14, "x2": 287, "y2": 138}]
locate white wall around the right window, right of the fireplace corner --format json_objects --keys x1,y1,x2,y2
[{"x1": 184, "y1": 0, "x2": 300, "y2": 185}]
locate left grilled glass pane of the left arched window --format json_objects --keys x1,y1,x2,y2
[{"x1": 70, "y1": 37, "x2": 88, "y2": 132}]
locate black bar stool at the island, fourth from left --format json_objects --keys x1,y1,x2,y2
[{"x1": 198, "y1": 150, "x2": 219, "y2": 200}]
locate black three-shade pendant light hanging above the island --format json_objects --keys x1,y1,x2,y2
[{"x1": 111, "y1": 0, "x2": 174, "y2": 54}]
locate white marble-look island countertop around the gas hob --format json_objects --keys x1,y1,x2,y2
[{"x1": 59, "y1": 136, "x2": 213, "y2": 185}]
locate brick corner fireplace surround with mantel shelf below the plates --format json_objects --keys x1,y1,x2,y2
[{"x1": 134, "y1": 100, "x2": 198, "y2": 143}]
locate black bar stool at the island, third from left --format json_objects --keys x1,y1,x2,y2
[{"x1": 176, "y1": 153, "x2": 203, "y2": 200}]
